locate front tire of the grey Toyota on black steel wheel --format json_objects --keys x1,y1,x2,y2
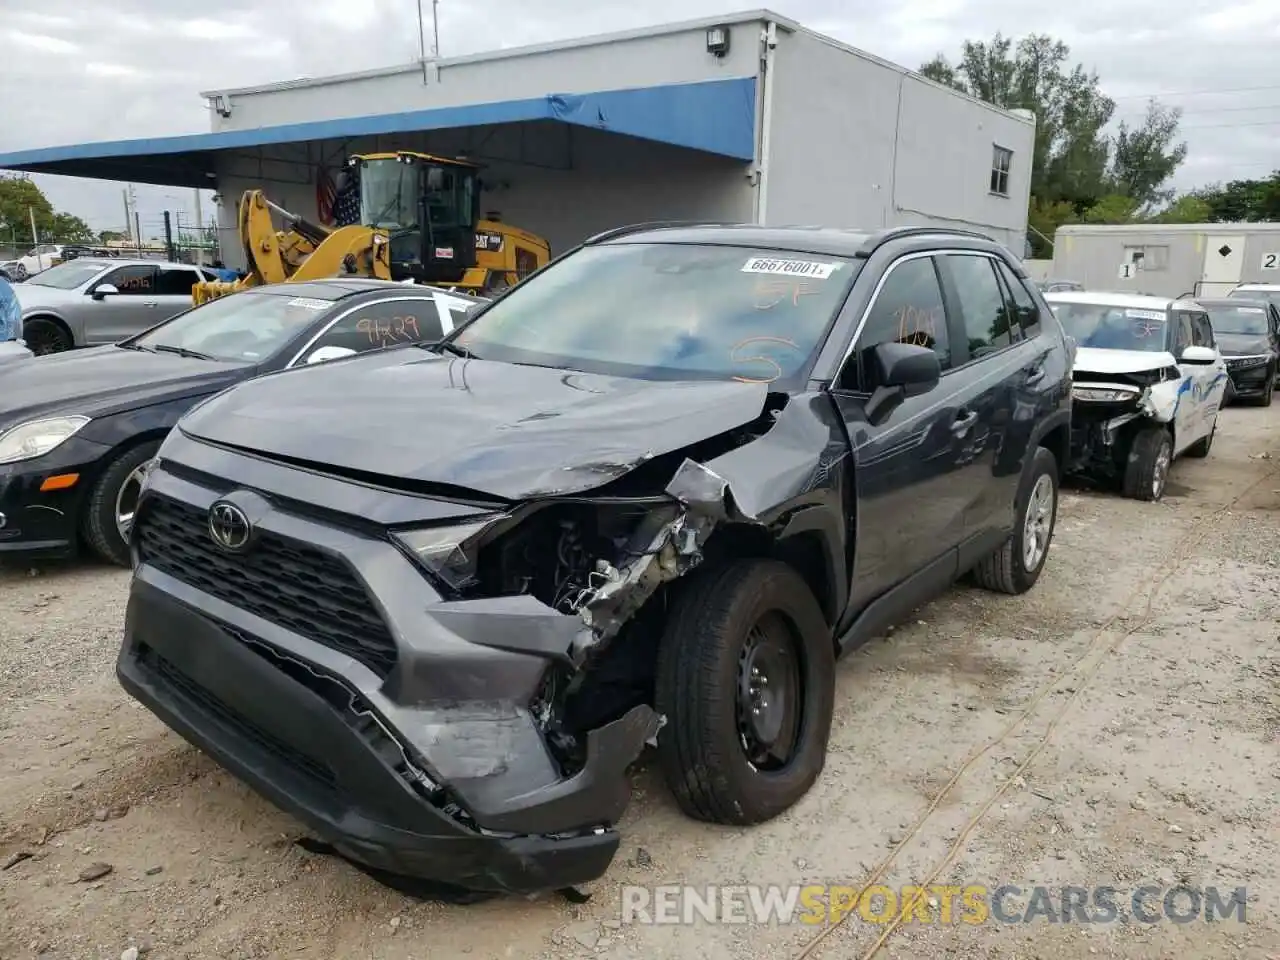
[{"x1": 655, "y1": 559, "x2": 836, "y2": 826}]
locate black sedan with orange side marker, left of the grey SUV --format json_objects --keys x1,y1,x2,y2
[{"x1": 0, "y1": 279, "x2": 480, "y2": 566}]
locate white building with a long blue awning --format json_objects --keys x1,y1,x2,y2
[{"x1": 0, "y1": 10, "x2": 1034, "y2": 266}]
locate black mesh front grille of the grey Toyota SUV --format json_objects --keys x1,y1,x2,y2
[{"x1": 134, "y1": 495, "x2": 396, "y2": 677}]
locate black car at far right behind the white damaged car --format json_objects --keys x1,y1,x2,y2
[{"x1": 1199, "y1": 294, "x2": 1280, "y2": 407}]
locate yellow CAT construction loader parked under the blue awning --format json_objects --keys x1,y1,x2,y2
[{"x1": 192, "y1": 151, "x2": 550, "y2": 305}]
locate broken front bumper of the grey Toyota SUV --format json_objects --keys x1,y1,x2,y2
[{"x1": 118, "y1": 466, "x2": 658, "y2": 893}]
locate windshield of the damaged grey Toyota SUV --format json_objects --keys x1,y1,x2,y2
[{"x1": 458, "y1": 243, "x2": 856, "y2": 383}]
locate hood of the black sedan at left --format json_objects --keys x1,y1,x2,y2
[{"x1": 0, "y1": 347, "x2": 247, "y2": 425}]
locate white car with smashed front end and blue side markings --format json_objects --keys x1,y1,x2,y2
[{"x1": 1044, "y1": 291, "x2": 1228, "y2": 500}]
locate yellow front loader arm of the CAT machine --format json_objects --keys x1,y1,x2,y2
[{"x1": 192, "y1": 189, "x2": 392, "y2": 306}]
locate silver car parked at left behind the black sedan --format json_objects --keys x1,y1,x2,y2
[{"x1": 14, "y1": 257, "x2": 216, "y2": 356}]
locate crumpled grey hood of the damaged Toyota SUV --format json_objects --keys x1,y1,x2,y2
[{"x1": 179, "y1": 348, "x2": 767, "y2": 500}]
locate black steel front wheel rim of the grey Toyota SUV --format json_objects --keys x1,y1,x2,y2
[{"x1": 736, "y1": 613, "x2": 804, "y2": 772}]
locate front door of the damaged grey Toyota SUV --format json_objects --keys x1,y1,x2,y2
[{"x1": 832, "y1": 255, "x2": 979, "y2": 611}]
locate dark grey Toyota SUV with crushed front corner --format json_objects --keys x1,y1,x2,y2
[{"x1": 118, "y1": 225, "x2": 1071, "y2": 891}]
